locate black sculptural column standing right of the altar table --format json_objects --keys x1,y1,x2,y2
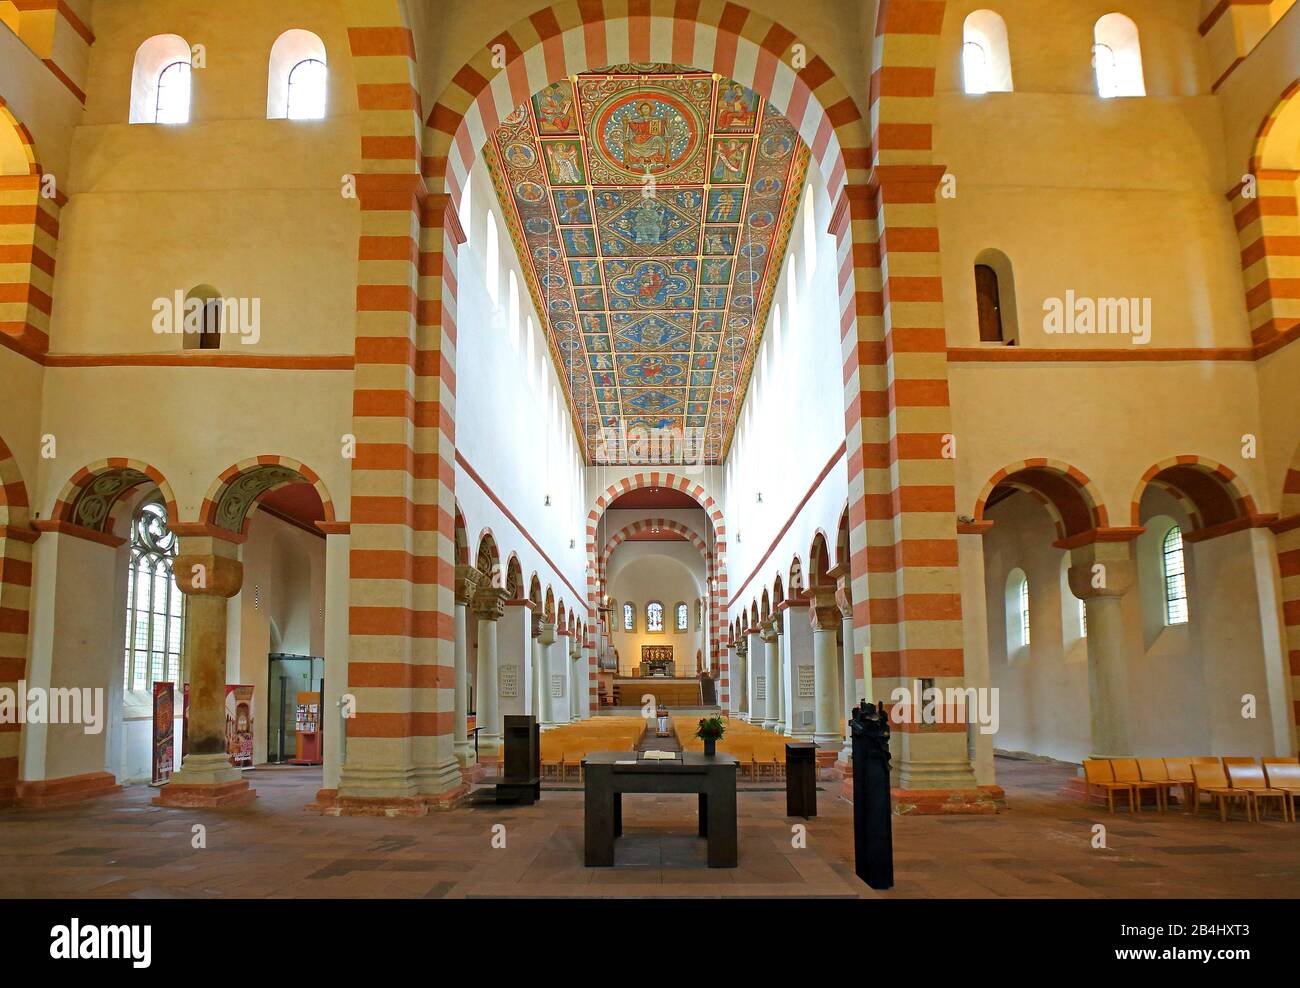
[{"x1": 849, "y1": 699, "x2": 893, "y2": 889}]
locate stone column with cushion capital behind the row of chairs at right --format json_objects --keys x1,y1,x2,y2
[{"x1": 1069, "y1": 541, "x2": 1136, "y2": 758}]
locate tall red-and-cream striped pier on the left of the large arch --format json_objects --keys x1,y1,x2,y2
[{"x1": 338, "y1": 0, "x2": 464, "y2": 813}]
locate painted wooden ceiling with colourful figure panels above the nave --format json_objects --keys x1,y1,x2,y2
[{"x1": 486, "y1": 65, "x2": 809, "y2": 463}]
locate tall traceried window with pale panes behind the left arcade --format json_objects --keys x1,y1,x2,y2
[{"x1": 122, "y1": 497, "x2": 183, "y2": 690}]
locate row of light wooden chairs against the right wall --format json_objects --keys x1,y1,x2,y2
[{"x1": 1083, "y1": 755, "x2": 1300, "y2": 822}]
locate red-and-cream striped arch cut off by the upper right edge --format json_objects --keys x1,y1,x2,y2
[{"x1": 1227, "y1": 79, "x2": 1300, "y2": 343}]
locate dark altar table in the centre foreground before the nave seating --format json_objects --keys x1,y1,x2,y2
[{"x1": 582, "y1": 751, "x2": 740, "y2": 868}]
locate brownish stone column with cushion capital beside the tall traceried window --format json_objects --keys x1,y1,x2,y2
[{"x1": 153, "y1": 536, "x2": 257, "y2": 807}]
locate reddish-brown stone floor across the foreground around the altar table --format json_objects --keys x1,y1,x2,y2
[{"x1": 0, "y1": 759, "x2": 1300, "y2": 898}]
